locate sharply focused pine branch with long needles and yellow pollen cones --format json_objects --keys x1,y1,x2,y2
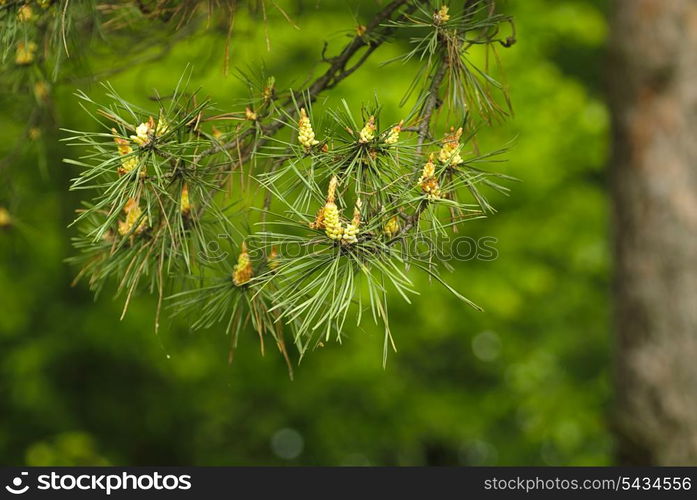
[{"x1": 59, "y1": 0, "x2": 508, "y2": 368}]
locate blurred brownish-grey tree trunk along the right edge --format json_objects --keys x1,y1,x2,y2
[{"x1": 609, "y1": 0, "x2": 697, "y2": 465}]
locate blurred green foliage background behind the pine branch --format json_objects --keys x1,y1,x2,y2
[{"x1": 0, "y1": 0, "x2": 613, "y2": 465}]
